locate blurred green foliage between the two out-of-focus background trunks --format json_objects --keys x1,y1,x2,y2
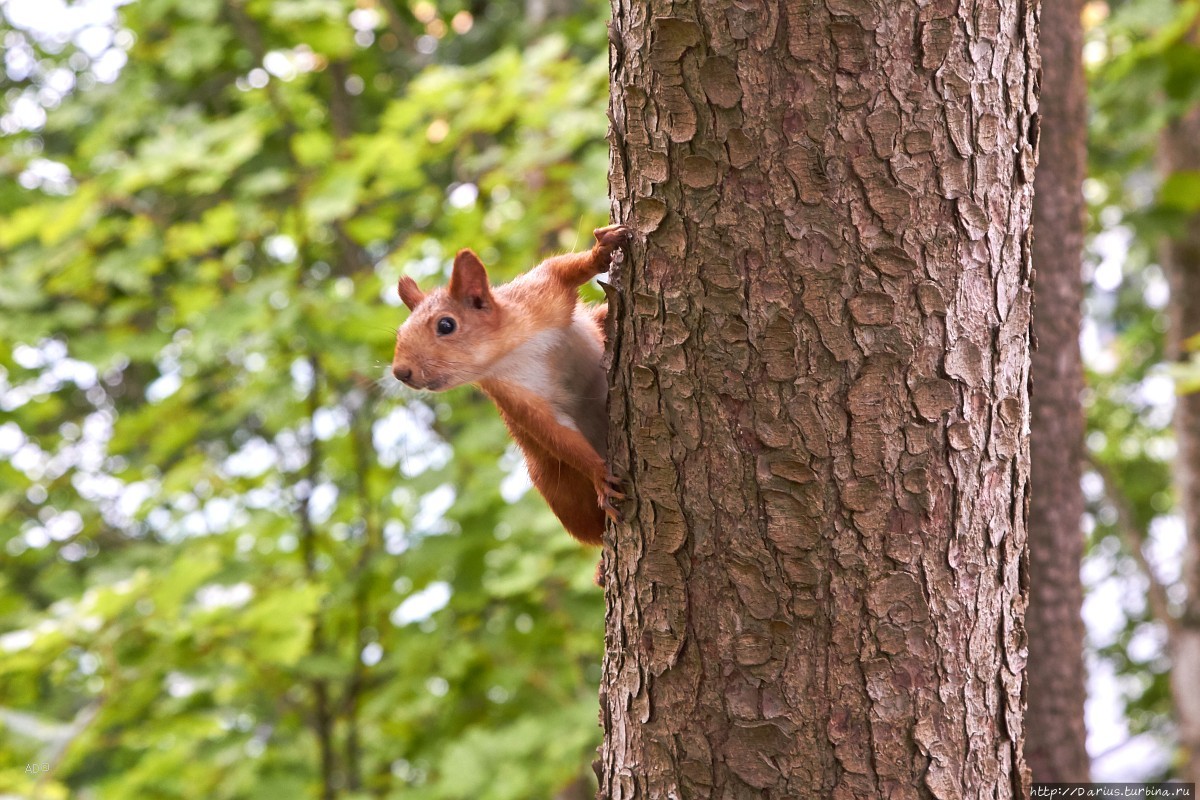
[{"x1": 1085, "y1": 0, "x2": 1200, "y2": 780}]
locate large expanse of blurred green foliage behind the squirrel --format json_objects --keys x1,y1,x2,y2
[{"x1": 0, "y1": 0, "x2": 608, "y2": 800}]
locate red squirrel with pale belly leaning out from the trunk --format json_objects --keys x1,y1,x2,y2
[{"x1": 391, "y1": 225, "x2": 631, "y2": 545}]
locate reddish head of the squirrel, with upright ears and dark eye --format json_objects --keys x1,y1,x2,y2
[{"x1": 391, "y1": 249, "x2": 502, "y2": 391}]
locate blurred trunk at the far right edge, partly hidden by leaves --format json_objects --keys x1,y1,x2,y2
[{"x1": 1162, "y1": 103, "x2": 1200, "y2": 783}]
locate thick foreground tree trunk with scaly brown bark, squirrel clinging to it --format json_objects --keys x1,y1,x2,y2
[{"x1": 599, "y1": 0, "x2": 1038, "y2": 800}]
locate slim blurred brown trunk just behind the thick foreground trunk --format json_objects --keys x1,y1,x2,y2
[{"x1": 1025, "y1": 0, "x2": 1090, "y2": 782}]
